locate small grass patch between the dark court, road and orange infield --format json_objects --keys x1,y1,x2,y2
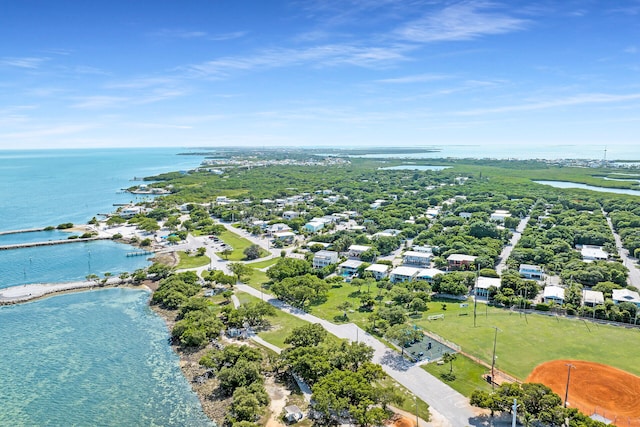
[{"x1": 422, "y1": 354, "x2": 491, "y2": 397}]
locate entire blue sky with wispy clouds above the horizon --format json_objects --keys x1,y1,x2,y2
[{"x1": 0, "y1": 0, "x2": 640, "y2": 152}]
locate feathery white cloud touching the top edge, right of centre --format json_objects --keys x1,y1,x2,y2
[{"x1": 395, "y1": 1, "x2": 529, "y2": 43}]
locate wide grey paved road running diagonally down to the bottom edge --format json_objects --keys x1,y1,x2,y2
[{"x1": 237, "y1": 285, "x2": 483, "y2": 427}]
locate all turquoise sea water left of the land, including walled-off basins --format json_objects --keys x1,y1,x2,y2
[{"x1": 0, "y1": 148, "x2": 211, "y2": 426}]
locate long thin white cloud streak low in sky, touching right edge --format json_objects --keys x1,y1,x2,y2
[{"x1": 454, "y1": 93, "x2": 640, "y2": 116}]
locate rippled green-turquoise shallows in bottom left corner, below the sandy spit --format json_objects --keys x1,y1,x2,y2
[{"x1": 0, "y1": 289, "x2": 211, "y2": 427}]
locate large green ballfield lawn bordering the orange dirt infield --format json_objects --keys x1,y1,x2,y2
[{"x1": 414, "y1": 303, "x2": 640, "y2": 380}]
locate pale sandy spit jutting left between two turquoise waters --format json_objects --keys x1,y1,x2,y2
[{"x1": 0, "y1": 278, "x2": 151, "y2": 306}]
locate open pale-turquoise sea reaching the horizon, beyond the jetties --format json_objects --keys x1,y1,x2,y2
[{"x1": 0, "y1": 148, "x2": 202, "y2": 234}]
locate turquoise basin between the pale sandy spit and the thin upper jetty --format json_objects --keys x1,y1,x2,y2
[{"x1": 0, "y1": 240, "x2": 149, "y2": 289}]
